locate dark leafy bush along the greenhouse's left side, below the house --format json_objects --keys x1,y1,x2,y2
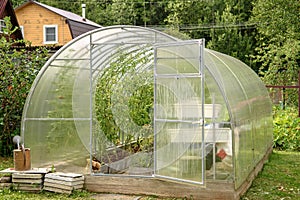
[{"x1": 0, "y1": 18, "x2": 48, "y2": 156}]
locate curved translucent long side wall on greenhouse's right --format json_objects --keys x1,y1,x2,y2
[{"x1": 205, "y1": 50, "x2": 272, "y2": 188}]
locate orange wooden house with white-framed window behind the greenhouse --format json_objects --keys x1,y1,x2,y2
[{"x1": 15, "y1": 1, "x2": 102, "y2": 46}]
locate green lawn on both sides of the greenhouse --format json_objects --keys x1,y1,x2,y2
[{"x1": 0, "y1": 151, "x2": 300, "y2": 200}]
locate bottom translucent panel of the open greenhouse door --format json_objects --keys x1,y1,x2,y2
[{"x1": 155, "y1": 121, "x2": 203, "y2": 182}]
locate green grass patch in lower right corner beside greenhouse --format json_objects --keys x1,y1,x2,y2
[{"x1": 241, "y1": 151, "x2": 300, "y2": 200}]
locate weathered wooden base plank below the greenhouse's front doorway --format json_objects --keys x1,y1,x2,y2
[{"x1": 85, "y1": 176, "x2": 237, "y2": 200}]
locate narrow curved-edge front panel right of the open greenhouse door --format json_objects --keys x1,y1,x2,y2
[{"x1": 204, "y1": 68, "x2": 234, "y2": 182}]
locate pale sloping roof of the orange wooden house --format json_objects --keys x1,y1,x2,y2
[{"x1": 15, "y1": 1, "x2": 102, "y2": 28}]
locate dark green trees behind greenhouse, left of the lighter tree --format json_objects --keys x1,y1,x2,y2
[{"x1": 13, "y1": 0, "x2": 262, "y2": 72}]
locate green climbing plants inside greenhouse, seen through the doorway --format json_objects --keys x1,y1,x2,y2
[{"x1": 95, "y1": 47, "x2": 153, "y2": 145}]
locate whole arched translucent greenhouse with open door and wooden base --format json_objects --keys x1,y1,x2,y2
[{"x1": 21, "y1": 26, "x2": 273, "y2": 199}]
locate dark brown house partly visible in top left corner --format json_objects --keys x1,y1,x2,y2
[{"x1": 0, "y1": 0, "x2": 23, "y2": 40}]
